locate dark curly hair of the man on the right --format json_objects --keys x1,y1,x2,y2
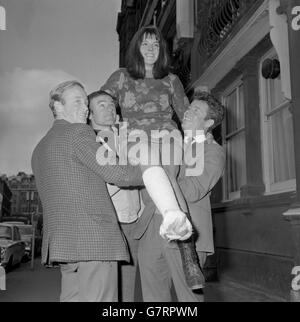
[{"x1": 193, "y1": 92, "x2": 225, "y2": 130}]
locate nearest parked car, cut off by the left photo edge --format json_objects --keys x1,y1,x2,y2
[{"x1": 0, "y1": 223, "x2": 25, "y2": 268}]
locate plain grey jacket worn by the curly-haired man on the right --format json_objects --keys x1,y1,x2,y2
[{"x1": 135, "y1": 142, "x2": 225, "y2": 253}]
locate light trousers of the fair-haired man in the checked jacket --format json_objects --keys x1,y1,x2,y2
[{"x1": 60, "y1": 261, "x2": 118, "y2": 302}]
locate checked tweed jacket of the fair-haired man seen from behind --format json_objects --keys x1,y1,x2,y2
[{"x1": 31, "y1": 120, "x2": 142, "y2": 264}]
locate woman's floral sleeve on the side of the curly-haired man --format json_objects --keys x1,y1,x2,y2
[{"x1": 170, "y1": 74, "x2": 190, "y2": 122}]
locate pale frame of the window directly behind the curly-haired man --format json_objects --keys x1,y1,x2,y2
[{"x1": 221, "y1": 75, "x2": 245, "y2": 201}]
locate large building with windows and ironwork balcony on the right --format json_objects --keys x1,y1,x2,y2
[{"x1": 117, "y1": 0, "x2": 300, "y2": 299}]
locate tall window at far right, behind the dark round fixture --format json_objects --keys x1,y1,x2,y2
[{"x1": 260, "y1": 49, "x2": 296, "y2": 194}]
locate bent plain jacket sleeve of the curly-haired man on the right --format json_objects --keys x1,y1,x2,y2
[{"x1": 178, "y1": 149, "x2": 225, "y2": 203}]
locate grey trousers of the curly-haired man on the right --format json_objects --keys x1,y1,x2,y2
[{"x1": 138, "y1": 214, "x2": 205, "y2": 302}]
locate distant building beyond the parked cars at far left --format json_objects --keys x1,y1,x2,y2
[{"x1": 8, "y1": 172, "x2": 43, "y2": 221}]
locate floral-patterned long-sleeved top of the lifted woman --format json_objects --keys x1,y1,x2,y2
[{"x1": 101, "y1": 68, "x2": 189, "y2": 134}]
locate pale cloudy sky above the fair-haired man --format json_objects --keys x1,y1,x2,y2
[{"x1": 0, "y1": 0, "x2": 121, "y2": 176}]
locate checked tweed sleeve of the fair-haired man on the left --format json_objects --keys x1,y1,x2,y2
[{"x1": 73, "y1": 124, "x2": 143, "y2": 186}]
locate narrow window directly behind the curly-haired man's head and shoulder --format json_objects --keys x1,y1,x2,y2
[{"x1": 223, "y1": 80, "x2": 246, "y2": 200}]
